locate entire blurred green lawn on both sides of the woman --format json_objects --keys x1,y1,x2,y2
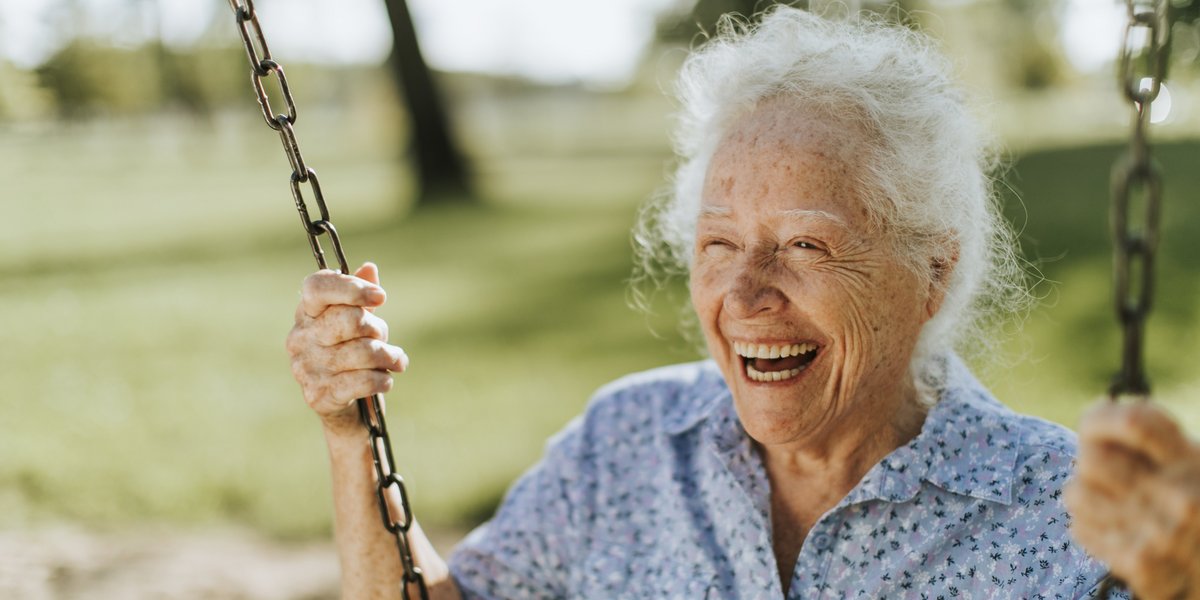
[{"x1": 0, "y1": 103, "x2": 1200, "y2": 536}]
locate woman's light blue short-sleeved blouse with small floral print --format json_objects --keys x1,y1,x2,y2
[{"x1": 450, "y1": 359, "x2": 1104, "y2": 600}]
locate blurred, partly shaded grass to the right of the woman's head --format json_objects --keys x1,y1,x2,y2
[{"x1": 989, "y1": 142, "x2": 1200, "y2": 431}]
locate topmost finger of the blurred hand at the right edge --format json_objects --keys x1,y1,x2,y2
[{"x1": 1079, "y1": 402, "x2": 1188, "y2": 466}]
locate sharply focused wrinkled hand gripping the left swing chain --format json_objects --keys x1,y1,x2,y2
[{"x1": 287, "y1": 263, "x2": 408, "y2": 433}]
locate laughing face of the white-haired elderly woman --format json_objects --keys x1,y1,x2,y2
[{"x1": 691, "y1": 101, "x2": 941, "y2": 444}]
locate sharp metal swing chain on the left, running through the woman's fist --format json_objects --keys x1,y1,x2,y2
[{"x1": 228, "y1": 0, "x2": 428, "y2": 600}]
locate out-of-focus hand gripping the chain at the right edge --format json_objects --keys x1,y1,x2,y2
[{"x1": 1063, "y1": 402, "x2": 1200, "y2": 600}]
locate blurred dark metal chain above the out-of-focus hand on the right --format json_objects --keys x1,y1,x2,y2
[{"x1": 1098, "y1": 0, "x2": 1170, "y2": 599}]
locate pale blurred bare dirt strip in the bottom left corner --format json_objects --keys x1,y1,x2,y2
[{"x1": 0, "y1": 527, "x2": 457, "y2": 600}]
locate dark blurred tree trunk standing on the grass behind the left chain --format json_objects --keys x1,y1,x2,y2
[{"x1": 384, "y1": 0, "x2": 472, "y2": 206}]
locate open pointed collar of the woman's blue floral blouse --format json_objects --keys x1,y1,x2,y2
[{"x1": 662, "y1": 355, "x2": 1020, "y2": 504}]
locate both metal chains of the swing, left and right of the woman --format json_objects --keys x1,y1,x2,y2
[{"x1": 228, "y1": 0, "x2": 1171, "y2": 600}]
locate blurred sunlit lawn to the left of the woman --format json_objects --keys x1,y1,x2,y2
[{"x1": 0, "y1": 108, "x2": 694, "y2": 536}]
